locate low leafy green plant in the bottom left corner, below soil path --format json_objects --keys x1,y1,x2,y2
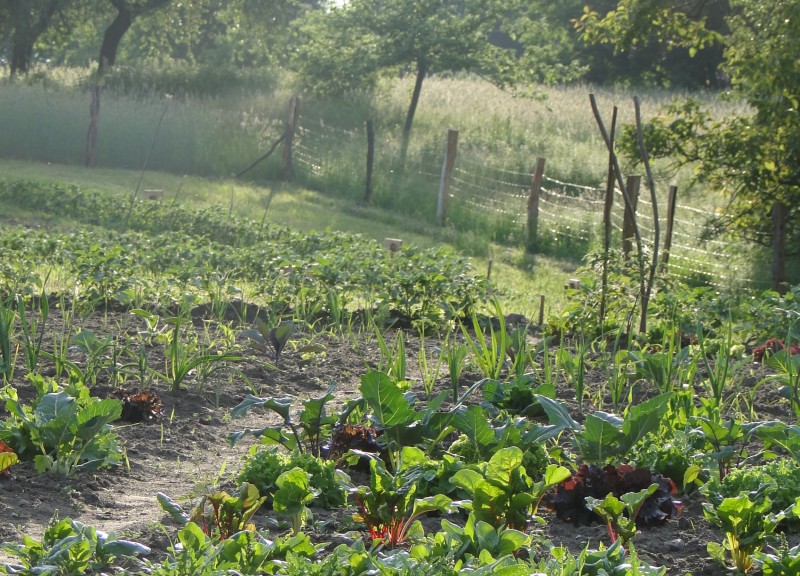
[{"x1": 0, "y1": 515, "x2": 150, "y2": 575}]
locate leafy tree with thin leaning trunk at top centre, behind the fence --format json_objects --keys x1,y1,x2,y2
[{"x1": 295, "y1": 0, "x2": 513, "y2": 154}]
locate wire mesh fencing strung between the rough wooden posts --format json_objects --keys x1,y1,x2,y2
[{"x1": 295, "y1": 117, "x2": 771, "y2": 288}]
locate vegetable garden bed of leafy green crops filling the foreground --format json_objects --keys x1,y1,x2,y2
[{"x1": 0, "y1": 183, "x2": 800, "y2": 575}]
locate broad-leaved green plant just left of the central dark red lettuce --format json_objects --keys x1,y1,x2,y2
[{"x1": 228, "y1": 384, "x2": 336, "y2": 456}]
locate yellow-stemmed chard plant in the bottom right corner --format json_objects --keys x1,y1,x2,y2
[{"x1": 703, "y1": 494, "x2": 800, "y2": 572}]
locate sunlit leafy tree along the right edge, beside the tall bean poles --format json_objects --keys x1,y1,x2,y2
[{"x1": 583, "y1": 0, "x2": 800, "y2": 290}]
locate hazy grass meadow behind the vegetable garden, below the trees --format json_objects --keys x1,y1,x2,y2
[{"x1": 0, "y1": 71, "x2": 776, "y2": 317}]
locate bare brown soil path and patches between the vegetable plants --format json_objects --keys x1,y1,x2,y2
[{"x1": 0, "y1": 310, "x2": 796, "y2": 576}]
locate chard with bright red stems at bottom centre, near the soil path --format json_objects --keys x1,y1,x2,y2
[{"x1": 352, "y1": 458, "x2": 453, "y2": 547}]
